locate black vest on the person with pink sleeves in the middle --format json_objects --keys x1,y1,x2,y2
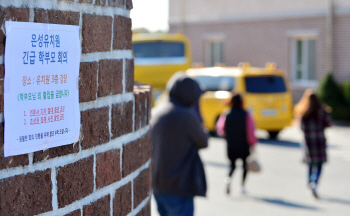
[{"x1": 225, "y1": 108, "x2": 250, "y2": 160}]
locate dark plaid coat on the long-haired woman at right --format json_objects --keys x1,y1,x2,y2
[{"x1": 301, "y1": 110, "x2": 331, "y2": 164}]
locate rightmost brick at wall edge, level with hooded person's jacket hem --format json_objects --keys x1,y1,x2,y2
[{"x1": 134, "y1": 169, "x2": 151, "y2": 208}]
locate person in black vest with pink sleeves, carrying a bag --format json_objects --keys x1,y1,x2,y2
[{"x1": 217, "y1": 94, "x2": 257, "y2": 194}]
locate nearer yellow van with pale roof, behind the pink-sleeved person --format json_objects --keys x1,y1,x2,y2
[{"x1": 186, "y1": 63, "x2": 293, "y2": 138}]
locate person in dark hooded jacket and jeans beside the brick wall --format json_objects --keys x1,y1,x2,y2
[{"x1": 151, "y1": 73, "x2": 208, "y2": 216}]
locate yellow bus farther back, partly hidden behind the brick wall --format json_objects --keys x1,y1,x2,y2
[{"x1": 132, "y1": 33, "x2": 192, "y2": 102}]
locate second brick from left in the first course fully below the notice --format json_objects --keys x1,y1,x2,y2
[{"x1": 57, "y1": 156, "x2": 94, "y2": 208}]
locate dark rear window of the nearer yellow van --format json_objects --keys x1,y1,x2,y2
[{"x1": 245, "y1": 76, "x2": 287, "y2": 93}]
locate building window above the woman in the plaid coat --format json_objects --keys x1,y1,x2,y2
[{"x1": 294, "y1": 38, "x2": 316, "y2": 81}]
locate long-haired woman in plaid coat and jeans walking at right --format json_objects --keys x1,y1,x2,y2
[{"x1": 295, "y1": 89, "x2": 332, "y2": 198}]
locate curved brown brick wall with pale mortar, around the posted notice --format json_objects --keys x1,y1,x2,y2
[{"x1": 0, "y1": 0, "x2": 151, "y2": 216}]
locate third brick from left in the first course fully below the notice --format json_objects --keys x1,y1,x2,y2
[{"x1": 96, "y1": 149, "x2": 121, "y2": 188}]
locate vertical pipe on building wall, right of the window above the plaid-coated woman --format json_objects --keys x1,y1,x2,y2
[{"x1": 326, "y1": 0, "x2": 333, "y2": 72}]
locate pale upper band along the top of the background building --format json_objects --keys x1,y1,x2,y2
[{"x1": 169, "y1": 0, "x2": 350, "y2": 23}]
